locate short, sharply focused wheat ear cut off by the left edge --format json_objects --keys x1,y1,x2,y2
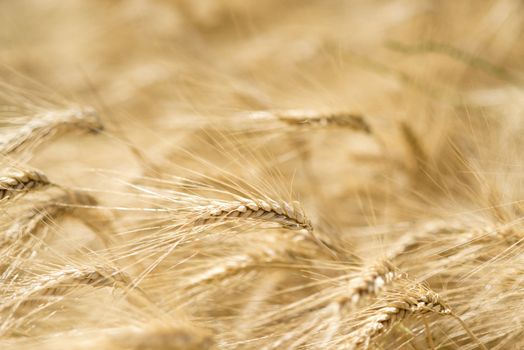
[{"x1": 0, "y1": 169, "x2": 53, "y2": 203}]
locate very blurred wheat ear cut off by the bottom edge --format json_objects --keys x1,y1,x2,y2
[{"x1": 104, "y1": 322, "x2": 216, "y2": 350}]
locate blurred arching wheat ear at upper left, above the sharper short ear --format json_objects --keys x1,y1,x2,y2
[{"x1": 0, "y1": 107, "x2": 104, "y2": 155}]
